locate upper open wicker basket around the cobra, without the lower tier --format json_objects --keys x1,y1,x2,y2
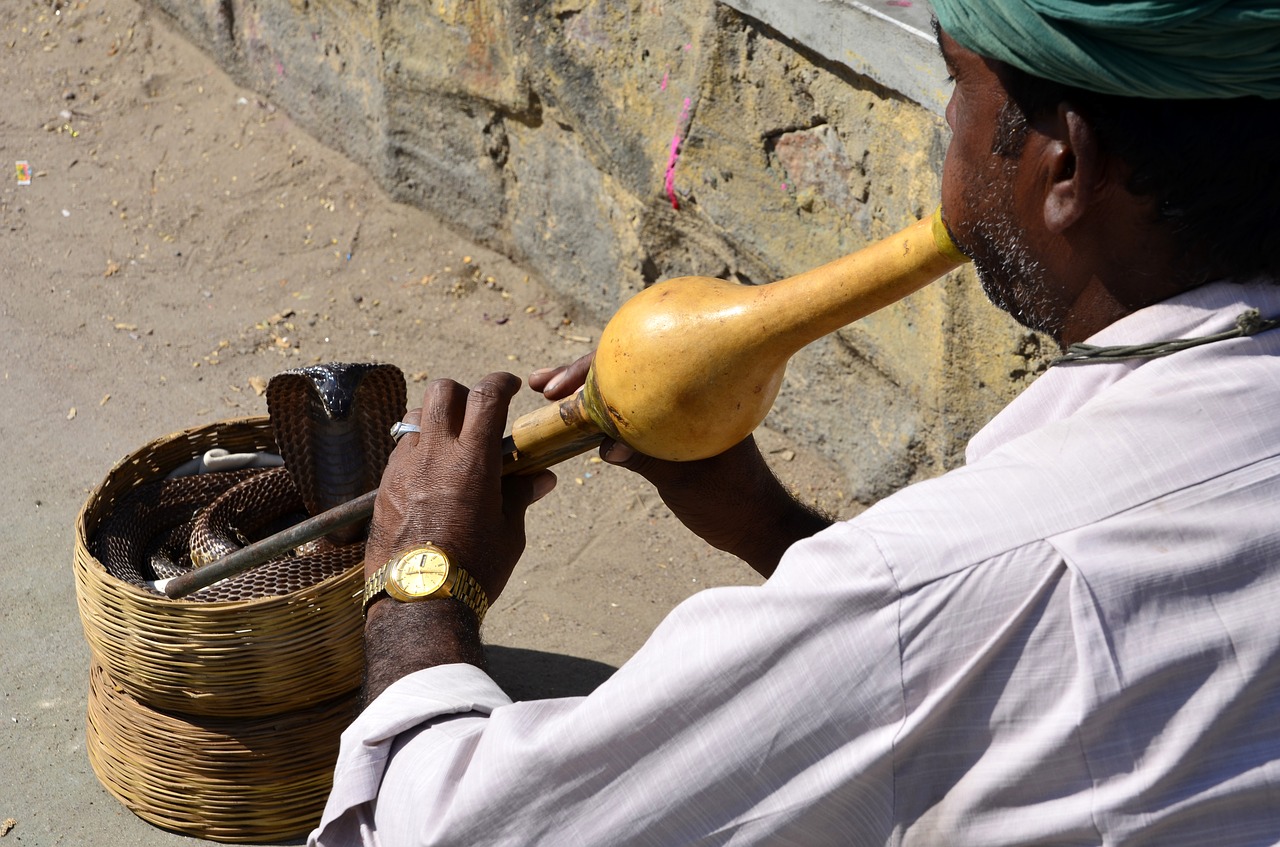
[{"x1": 74, "y1": 417, "x2": 364, "y2": 716}]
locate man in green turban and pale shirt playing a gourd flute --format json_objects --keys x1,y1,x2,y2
[{"x1": 312, "y1": 0, "x2": 1280, "y2": 847}]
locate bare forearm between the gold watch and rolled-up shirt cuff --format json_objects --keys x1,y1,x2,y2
[{"x1": 365, "y1": 598, "x2": 485, "y2": 705}]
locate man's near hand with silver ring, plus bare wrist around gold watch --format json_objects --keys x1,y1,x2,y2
[{"x1": 365, "y1": 374, "x2": 556, "y2": 700}]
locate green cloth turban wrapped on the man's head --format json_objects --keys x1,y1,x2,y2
[{"x1": 933, "y1": 0, "x2": 1280, "y2": 100}]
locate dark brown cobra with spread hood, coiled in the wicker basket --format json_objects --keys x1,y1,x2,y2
[{"x1": 93, "y1": 363, "x2": 406, "y2": 603}]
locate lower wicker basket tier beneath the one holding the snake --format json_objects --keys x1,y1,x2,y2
[{"x1": 86, "y1": 663, "x2": 358, "y2": 843}]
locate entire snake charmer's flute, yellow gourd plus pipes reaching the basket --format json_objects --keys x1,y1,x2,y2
[{"x1": 157, "y1": 210, "x2": 968, "y2": 599}]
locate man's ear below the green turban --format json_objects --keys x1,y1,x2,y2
[{"x1": 1041, "y1": 102, "x2": 1103, "y2": 233}]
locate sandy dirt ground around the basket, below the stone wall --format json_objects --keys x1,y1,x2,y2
[{"x1": 0, "y1": 0, "x2": 850, "y2": 847}]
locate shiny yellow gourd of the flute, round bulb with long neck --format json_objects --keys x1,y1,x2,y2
[{"x1": 585, "y1": 212, "x2": 968, "y2": 461}]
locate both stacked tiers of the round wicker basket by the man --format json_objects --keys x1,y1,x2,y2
[{"x1": 74, "y1": 417, "x2": 364, "y2": 842}]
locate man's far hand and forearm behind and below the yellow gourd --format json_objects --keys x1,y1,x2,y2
[{"x1": 529, "y1": 353, "x2": 832, "y2": 577}]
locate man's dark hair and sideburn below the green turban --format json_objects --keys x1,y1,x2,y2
[{"x1": 996, "y1": 64, "x2": 1280, "y2": 283}]
